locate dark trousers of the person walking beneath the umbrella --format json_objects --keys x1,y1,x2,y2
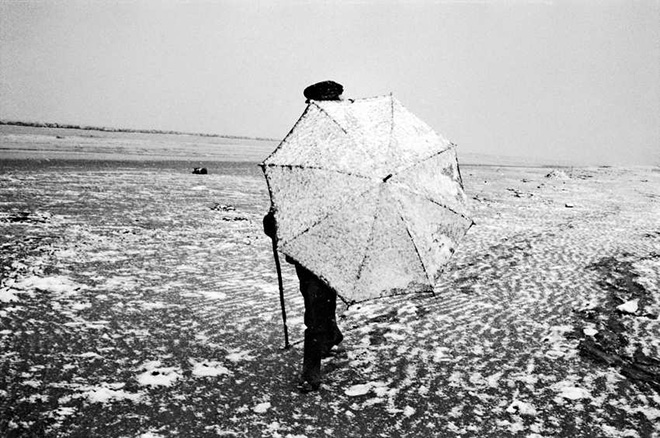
[{"x1": 296, "y1": 263, "x2": 343, "y2": 384}]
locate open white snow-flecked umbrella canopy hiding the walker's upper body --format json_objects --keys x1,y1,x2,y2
[{"x1": 261, "y1": 95, "x2": 473, "y2": 302}]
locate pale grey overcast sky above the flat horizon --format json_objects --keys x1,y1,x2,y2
[{"x1": 0, "y1": 0, "x2": 660, "y2": 164}]
